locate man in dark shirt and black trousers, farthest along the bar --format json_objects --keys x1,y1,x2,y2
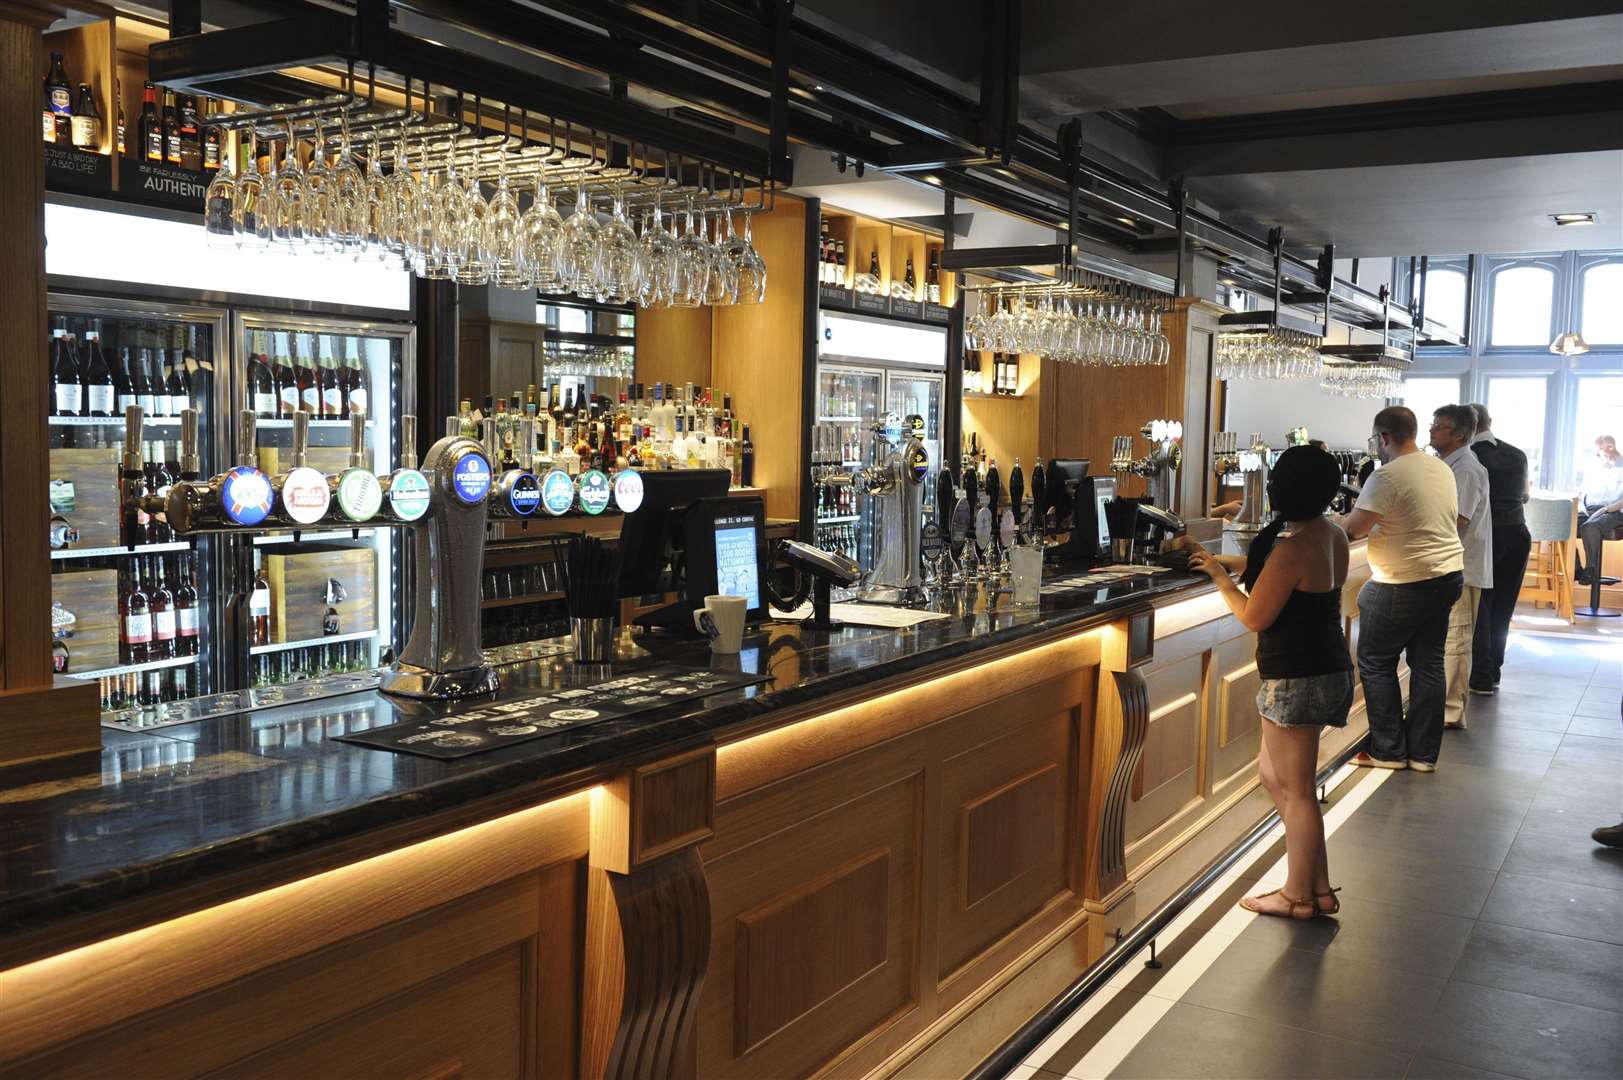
[{"x1": 1470, "y1": 404, "x2": 1532, "y2": 693}]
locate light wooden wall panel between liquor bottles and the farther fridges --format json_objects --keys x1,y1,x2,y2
[{"x1": 711, "y1": 195, "x2": 807, "y2": 518}]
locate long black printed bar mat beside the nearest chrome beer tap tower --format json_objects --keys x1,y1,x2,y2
[{"x1": 338, "y1": 663, "x2": 771, "y2": 760}]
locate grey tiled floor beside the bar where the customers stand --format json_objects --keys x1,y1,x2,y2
[{"x1": 1032, "y1": 635, "x2": 1623, "y2": 1080}]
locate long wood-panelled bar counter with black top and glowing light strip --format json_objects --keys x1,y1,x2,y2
[{"x1": 0, "y1": 552, "x2": 1362, "y2": 1077}]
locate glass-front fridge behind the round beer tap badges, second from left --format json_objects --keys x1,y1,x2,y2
[{"x1": 232, "y1": 312, "x2": 415, "y2": 687}]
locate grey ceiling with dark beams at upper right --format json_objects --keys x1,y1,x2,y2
[{"x1": 797, "y1": 0, "x2": 1623, "y2": 258}]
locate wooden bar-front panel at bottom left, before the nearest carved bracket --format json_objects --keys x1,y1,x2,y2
[{"x1": 0, "y1": 864, "x2": 558, "y2": 1080}]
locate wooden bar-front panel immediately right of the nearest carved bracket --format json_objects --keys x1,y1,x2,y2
[{"x1": 698, "y1": 766, "x2": 928, "y2": 1078}]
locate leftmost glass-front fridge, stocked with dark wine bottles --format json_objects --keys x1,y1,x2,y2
[{"x1": 42, "y1": 292, "x2": 229, "y2": 711}]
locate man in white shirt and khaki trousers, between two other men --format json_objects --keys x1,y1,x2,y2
[{"x1": 1430, "y1": 404, "x2": 1493, "y2": 728}]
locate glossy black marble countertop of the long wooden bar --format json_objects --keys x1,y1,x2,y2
[{"x1": 0, "y1": 572, "x2": 1209, "y2": 945}]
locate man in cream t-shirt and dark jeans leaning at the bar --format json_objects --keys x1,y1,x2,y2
[{"x1": 1344, "y1": 404, "x2": 1464, "y2": 773}]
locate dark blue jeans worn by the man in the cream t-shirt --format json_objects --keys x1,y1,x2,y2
[{"x1": 1358, "y1": 570, "x2": 1466, "y2": 765}]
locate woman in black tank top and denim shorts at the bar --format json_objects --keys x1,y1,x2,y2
[{"x1": 1190, "y1": 447, "x2": 1354, "y2": 919}]
